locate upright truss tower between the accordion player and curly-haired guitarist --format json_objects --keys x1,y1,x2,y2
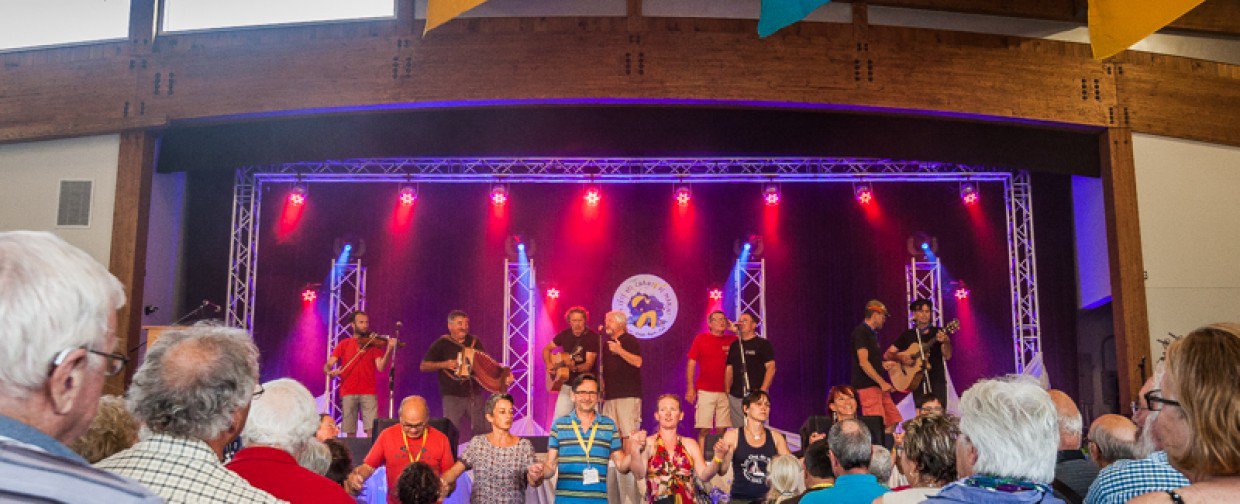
[{"x1": 503, "y1": 258, "x2": 538, "y2": 421}]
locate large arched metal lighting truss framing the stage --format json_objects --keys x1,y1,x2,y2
[{"x1": 227, "y1": 158, "x2": 1042, "y2": 372}]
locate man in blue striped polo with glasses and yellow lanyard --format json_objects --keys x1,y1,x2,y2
[{"x1": 529, "y1": 374, "x2": 630, "y2": 504}]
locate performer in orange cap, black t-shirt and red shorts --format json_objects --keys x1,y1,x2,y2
[{"x1": 852, "y1": 299, "x2": 900, "y2": 433}]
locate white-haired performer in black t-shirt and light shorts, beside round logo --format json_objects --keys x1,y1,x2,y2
[{"x1": 603, "y1": 310, "x2": 641, "y2": 504}]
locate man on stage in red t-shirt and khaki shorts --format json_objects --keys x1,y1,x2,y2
[{"x1": 684, "y1": 310, "x2": 737, "y2": 446}]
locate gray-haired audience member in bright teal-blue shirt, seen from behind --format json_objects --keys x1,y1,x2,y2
[{"x1": 800, "y1": 420, "x2": 888, "y2": 504}]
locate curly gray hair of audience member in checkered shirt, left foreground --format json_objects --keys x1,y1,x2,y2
[{"x1": 129, "y1": 325, "x2": 258, "y2": 439}]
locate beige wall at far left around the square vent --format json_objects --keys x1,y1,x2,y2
[{"x1": 0, "y1": 135, "x2": 120, "y2": 264}]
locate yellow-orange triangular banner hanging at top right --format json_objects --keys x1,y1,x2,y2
[{"x1": 1089, "y1": 0, "x2": 1204, "y2": 60}]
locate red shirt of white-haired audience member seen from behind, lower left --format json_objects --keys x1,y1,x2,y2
[{"x1": 226, "y1": 446, "x2": 355, "y2": 504}]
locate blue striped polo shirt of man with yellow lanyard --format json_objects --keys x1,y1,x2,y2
[{"x1": 547, "y1": 408, "x2": 624, "y2": 503}]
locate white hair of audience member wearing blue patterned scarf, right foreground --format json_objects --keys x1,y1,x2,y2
[{"x1": 960, "y1": 375, "x2": 1059, "y2": 483}]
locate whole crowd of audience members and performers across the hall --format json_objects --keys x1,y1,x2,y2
[{"x1": 0, "y1": 232, "x2": 1240, "y2": 504}]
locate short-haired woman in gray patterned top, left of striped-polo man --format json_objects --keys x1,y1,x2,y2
[{"x1": 443, "y1": 394, "x2": 539, "y2": 504}]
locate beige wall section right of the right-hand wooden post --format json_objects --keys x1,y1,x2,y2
[{"x1": 1132, "y1": 134, "x2": 1240, "y2": 360}]
